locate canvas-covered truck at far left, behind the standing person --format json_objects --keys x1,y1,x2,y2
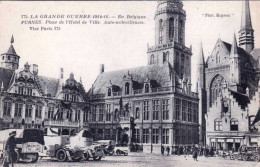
[{"x1": 0, "y1": 129, "x2": 45, "y2": 163}]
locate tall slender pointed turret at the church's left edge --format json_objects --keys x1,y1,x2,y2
[{"x1": 197, "y1": 44, "x2": 207, "y2": 144}]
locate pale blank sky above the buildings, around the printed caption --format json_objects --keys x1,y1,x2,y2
[{"x1": 0, "y1": 1, "x2": 260, "y2": 90}]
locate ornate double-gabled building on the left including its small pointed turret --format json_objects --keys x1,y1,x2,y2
[{"x1": 0, "y1": 37, "x2": 88, "y2": 134}]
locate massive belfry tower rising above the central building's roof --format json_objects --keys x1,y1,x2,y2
[{"x1": 147, "y1": 0, "x2": 192, "y2": 79}]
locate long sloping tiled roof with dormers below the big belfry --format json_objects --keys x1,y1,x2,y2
[{"x1": 90, "y1": 63, "x2": 172, "y2": 94}]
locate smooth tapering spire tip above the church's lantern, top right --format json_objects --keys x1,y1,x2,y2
[{"x1": 240, "y1": 0, "x2": 252, "y2": 31}]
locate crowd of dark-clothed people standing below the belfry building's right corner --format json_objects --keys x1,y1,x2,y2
[{"x1": 161, "y1": 146, "x2": 214, "y2": 161}]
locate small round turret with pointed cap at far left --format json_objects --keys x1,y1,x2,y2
[{"x1": 1, "y1": 36, "x2": 20, "y2": 70}]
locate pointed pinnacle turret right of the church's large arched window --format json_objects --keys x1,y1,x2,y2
[{"x1": 230, "y1": 34, "x2": 241, "y2": 91}]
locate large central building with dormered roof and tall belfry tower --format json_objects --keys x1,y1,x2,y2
[{"x1": 89, "y1": 0, "x2": 199, "y2": 152}]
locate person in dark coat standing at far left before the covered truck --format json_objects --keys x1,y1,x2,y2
[{"x1": 3, "y1": 131, "x2": 16, "y2": 167}]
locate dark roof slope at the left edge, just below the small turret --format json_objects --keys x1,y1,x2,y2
[{"x1": 0, "y1": 67, "x2": 14, "y2": 91}]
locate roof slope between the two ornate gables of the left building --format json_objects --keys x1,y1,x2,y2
[{"x1": 38, "y1": 76, "x2": 59, "y2": 97}]
